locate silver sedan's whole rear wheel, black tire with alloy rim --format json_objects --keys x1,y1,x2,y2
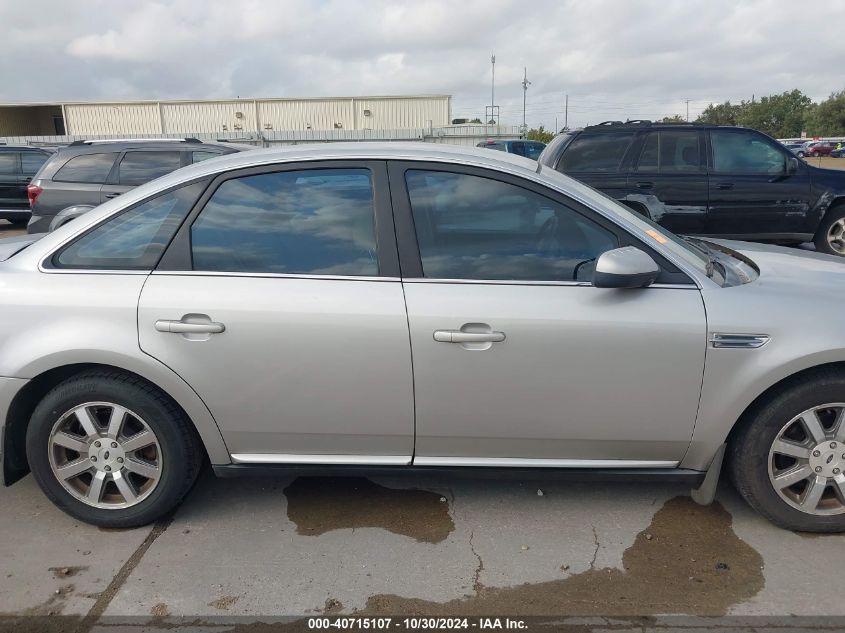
[{"x1": 26, "y1": 370, "x2": 204, "y2": 528}]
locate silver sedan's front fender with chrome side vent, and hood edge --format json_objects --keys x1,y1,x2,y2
[{"x1": 681, "y1": 242, "x2": 845, "y2": 470}]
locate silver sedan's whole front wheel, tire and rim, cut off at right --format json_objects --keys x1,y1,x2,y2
[{"x1": 728, "y1": 370, "x2": 845, "y2": 532}]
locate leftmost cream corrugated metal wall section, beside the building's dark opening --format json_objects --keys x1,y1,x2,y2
[{"x1": 65, "y1": 103, "x2": 163, "y2": 136}]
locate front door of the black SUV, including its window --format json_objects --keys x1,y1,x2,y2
[{"x1": 706, "y1": 128, "x2": 812, "y2": 240}]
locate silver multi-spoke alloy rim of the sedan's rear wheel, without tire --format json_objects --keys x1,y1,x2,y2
[{"x1": 48, "y1": 402, "x2": 162, "y2": 509}]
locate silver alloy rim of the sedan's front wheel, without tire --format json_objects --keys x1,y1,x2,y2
[{"x1": 768, "y1": 403, "x2": 845, "y2": 516}]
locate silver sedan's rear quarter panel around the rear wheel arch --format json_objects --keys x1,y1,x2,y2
[{"x1": 0, "y1": 257, "x2": 229, "y2": 464}]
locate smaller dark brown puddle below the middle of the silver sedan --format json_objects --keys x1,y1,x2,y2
[{"x1": 284, "y1": 477, "x2": 455, "y2": 543}]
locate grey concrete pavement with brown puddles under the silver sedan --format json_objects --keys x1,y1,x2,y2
[{"x1": 0, "y1": 473, "x2": 845, "y2": 618}]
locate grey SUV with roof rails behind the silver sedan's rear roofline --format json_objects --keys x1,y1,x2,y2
[{"x1": 27, "y1": 138, "x2": 247, "y2": 233}]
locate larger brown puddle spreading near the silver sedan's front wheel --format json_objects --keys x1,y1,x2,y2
[{"x1": 364, "y1": 497, "x2": 765, "y2": 616}]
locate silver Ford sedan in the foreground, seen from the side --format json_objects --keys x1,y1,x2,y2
[{"x1": 0, "y1": 143, "x2": 845, "y2": 532}]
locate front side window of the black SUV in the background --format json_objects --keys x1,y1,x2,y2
[{"x1": 710, "y1": 130, "x2": 786, "y2": 174}]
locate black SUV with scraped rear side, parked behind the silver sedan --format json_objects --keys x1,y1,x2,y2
[{"x1": 539, "y1": 121, "x2": 845, "y2": 255}]
